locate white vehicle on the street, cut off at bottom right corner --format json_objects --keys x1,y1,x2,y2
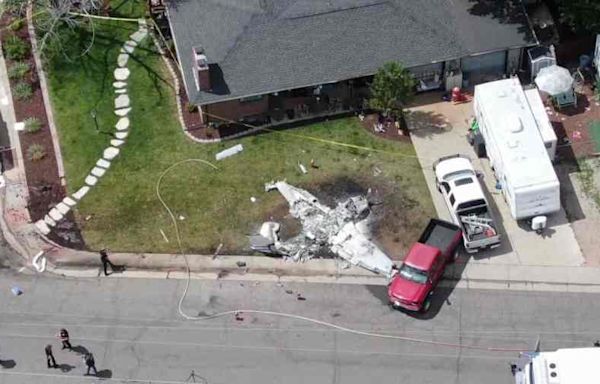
[{"x1": 512, "y1": 347, "x2": 600, "y2": 384}]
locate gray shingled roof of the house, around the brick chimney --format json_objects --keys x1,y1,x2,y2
[{"x1": 169, "y1": 0, "x2": 535, "y2": 104}]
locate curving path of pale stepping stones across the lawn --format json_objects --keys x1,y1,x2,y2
[{"x1": 35, "y1": 19, "x2": 148, "y2": 235}]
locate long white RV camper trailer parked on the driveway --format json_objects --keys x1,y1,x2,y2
[{"x1": 473, "y1": 78, "x2": 560, "y2": 222}]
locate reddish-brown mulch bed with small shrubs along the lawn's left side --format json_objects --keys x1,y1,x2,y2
[{"x1": 0, "y1": 15, "x2": 83, "y2": 248}]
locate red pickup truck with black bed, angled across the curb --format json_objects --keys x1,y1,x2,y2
[{"x1": 388, "y1": 219, "x2": 462, "y2": 312}]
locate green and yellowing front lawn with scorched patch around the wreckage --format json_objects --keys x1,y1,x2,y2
[{"x1": 47, "y1": 3, "x2": 434, "y2": 253}]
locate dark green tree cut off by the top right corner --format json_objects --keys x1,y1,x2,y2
[{"x1": 557, "y1": 0, "x2": 600, "y2": 33}]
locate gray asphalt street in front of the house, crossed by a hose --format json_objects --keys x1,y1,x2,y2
[{"x1": 0, "y1": 271, "x2": 600, "y2": 384}]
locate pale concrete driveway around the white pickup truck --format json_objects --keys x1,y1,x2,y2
[{"x1": 407, "y1": 94, "x2": 585, "y2": 266}]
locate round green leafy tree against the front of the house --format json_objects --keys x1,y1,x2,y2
[{"x1": 369, "y1": 62, "x2": 416, "y2": 116}]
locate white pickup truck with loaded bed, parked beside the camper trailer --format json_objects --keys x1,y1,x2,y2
[{"x1": 433, "y1": 155, "x2": 500, "y2": 253}]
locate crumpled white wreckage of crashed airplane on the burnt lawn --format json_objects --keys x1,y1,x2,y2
[{"x1": 250, "y1": 181, "x2": 393, "y2": 277}]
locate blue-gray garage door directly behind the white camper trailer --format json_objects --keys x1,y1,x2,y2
[{"x1": 460, "y1": 51, "x2": 506, "y2": 87}]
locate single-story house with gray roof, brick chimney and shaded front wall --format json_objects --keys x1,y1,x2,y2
[{"x1": 167, "y1": 0, "x2": 537, "y2": 126}]
